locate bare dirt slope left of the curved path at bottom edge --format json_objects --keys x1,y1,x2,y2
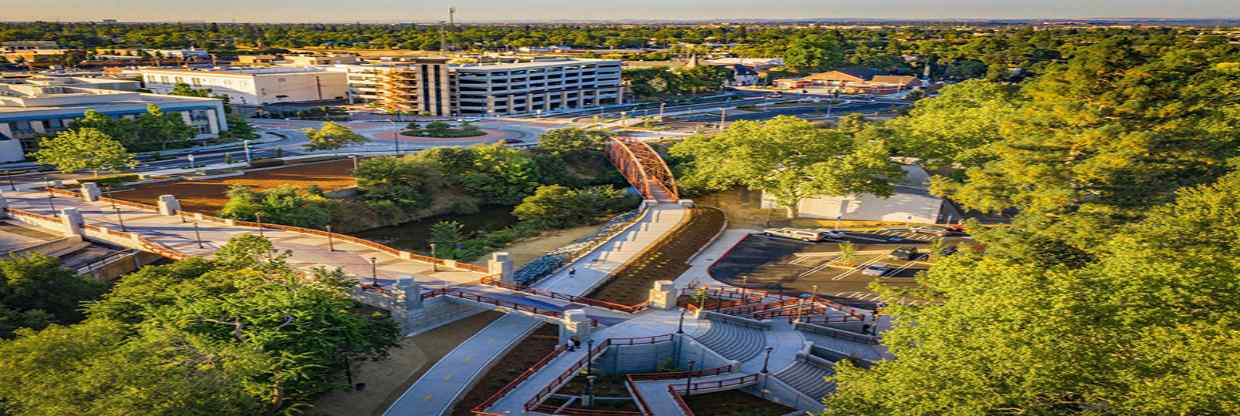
[{"x1": 310, "y1": 312, "x2": 503, "y2": 416}]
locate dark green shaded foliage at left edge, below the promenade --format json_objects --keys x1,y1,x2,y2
[{"x1": 0, "y1": 253, "x2": 105, "y2": 339}]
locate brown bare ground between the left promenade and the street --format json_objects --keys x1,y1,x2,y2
[{"x1": 110, "y1": 159, "x2": 357, "y2": 214}]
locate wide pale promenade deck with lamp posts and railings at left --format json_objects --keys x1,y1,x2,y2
[{"x1": 2, "y1": 190, "x2": 484, "y2": 286}]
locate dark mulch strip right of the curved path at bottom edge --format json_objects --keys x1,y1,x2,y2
[{"x1": 453, "y1": 324, "x2": 559, "y2": 416}]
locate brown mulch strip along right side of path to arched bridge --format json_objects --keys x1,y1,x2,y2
[{"x1": 590, "y1": 207, "x2": 724, "y2": 304}]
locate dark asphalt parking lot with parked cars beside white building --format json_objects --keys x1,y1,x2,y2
[{"x1": 711, "y1": 228, "x2": 962, "y2": 304}]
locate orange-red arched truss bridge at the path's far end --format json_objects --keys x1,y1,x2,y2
[{"x1": 606, "y1": 137, "x2": 680, "y2": 202}]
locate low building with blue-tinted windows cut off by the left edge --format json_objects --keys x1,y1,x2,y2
[{"x1": 0, "y1": 78, "x2": 228, "y2": 161}]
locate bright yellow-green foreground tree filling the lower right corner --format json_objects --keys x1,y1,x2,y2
[{"x1": 826, "y1": 173, "x2": 1240, "y2": 415}]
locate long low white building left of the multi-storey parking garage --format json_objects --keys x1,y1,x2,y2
[{"x1": 141, "y1": 67, "x2": 348, "y2": 106}]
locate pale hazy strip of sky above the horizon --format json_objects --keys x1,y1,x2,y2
[{"x1": 0, "y1": 0, "x2": 1240, "y2": 22}]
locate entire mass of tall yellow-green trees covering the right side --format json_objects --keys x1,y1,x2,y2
[{"x1": 827, "y1": 34, "x2": 1240, "y2": 415}]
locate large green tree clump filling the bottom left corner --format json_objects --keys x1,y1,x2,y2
[{"x1": 0, "y1": 235, "x2": 398, "y2": 415}]
